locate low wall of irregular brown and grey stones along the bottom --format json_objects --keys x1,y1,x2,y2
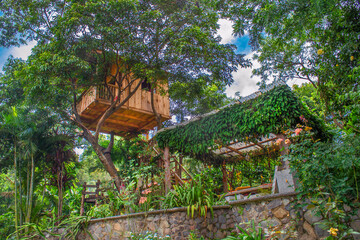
[{"x1": 78, "y1": 193, "x2": 360, "y2": 240}]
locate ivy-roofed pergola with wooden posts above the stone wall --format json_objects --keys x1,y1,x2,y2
[{"x1": 155, "y1": 83, "x2": 325, "y2": 195}]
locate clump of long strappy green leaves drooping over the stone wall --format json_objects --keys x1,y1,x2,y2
[{"x1": 163, "y1": 178, "x2": 221, "y2": 218}]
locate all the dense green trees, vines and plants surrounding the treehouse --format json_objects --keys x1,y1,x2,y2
[{"x1": 0, "y1": 0, "x2": 360, "y2": 239}]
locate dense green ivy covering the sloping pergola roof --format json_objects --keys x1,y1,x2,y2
[{"x1": 155, "y1": 85, "x2": 326, "y2": 156}]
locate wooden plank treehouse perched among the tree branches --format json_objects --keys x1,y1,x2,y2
[{"x1": 77, "y1": 64, "x2": 171, "y2": 136}]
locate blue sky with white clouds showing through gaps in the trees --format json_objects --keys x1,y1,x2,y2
[{"x1": 0, "y1": 19, "x2": 298, "y2": 97}]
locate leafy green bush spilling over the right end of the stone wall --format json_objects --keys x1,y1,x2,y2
[{"x1": 287, "y1": 131, "x2": 360, "y2": 236}]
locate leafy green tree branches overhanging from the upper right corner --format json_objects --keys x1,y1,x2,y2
[{"x1": 224, "y1": 0, "x2": 360, "y2": 133}]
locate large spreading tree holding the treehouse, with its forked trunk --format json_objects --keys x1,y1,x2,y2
[{"x1": 0, "y1": 0, "x2": 250, "y2": 191}]
